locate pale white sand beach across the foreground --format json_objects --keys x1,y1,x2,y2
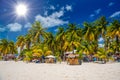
[{"x1": 0, "y1": 61, "x2": 120, "y2": 80}]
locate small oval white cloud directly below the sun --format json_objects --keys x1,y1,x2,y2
[{"x1": 7, "y1": 23, "x2": 22, "y2": 32}]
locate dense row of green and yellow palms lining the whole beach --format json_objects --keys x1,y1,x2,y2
[{"x1": 0, "y1": 16, "x2": 120, "y2": 61}]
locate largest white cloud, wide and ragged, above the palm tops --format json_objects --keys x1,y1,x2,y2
[{"x1": 35, "y1": 10, "x2": 68, "y2": 27}]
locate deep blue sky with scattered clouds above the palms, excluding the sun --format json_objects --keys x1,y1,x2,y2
[{"x1": 0, "y1": 0, "x2": 120, "y2": 41}]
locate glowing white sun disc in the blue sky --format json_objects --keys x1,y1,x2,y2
[{"x1": 16, "y1": 4, "x2": 28, "y2": 16}]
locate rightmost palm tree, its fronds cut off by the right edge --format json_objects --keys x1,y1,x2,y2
[{"x1": 107, "y1": 20, "x2": 120, "y2": 53}]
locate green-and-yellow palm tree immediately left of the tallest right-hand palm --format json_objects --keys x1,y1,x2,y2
[{"x1": 82, "y1": 22, "x2": 99, "y2": 53}]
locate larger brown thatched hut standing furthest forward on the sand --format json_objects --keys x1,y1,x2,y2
[{"x1": 67, "y1": 54, "x2": 80, "y2": 65}]
